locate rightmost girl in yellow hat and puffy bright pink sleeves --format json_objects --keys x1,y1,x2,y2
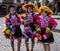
[{"x1": 36, "y1": 6, "x2": 57, "y2": 51}]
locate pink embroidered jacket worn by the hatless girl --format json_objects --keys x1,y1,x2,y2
[{"x1": 5, "y1": 14, "x2": 21, "y2": 26}]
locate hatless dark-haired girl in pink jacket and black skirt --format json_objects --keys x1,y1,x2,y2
[{"x1": 4, "y1": 5, "x2": 22, "y2": 51}]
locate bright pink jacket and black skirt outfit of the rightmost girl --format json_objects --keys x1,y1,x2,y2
[{"x1": 36, "y1": 16, "x2": 57, "y2": 43}]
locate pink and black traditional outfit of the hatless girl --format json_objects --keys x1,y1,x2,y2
[{"x1": 4, "y1": 14, "x2": 22, "y2": 39}]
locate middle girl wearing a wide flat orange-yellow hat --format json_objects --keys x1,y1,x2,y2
[{"x1": 22, "y1": 2, "x2": 37, "y2": 51}]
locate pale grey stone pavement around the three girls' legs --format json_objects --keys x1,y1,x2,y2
[{"x1": 0, "y1": 18, "x2": 60, "y2": 51}]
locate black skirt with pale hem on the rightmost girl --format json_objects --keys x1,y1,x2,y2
[{"x1": 38, "y1": 28, "x2": 54, "y2": 43}]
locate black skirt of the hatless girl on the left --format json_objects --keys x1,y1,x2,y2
[{"x1": 5, "y1": 26, "x2": 22, "y2": 39}]
